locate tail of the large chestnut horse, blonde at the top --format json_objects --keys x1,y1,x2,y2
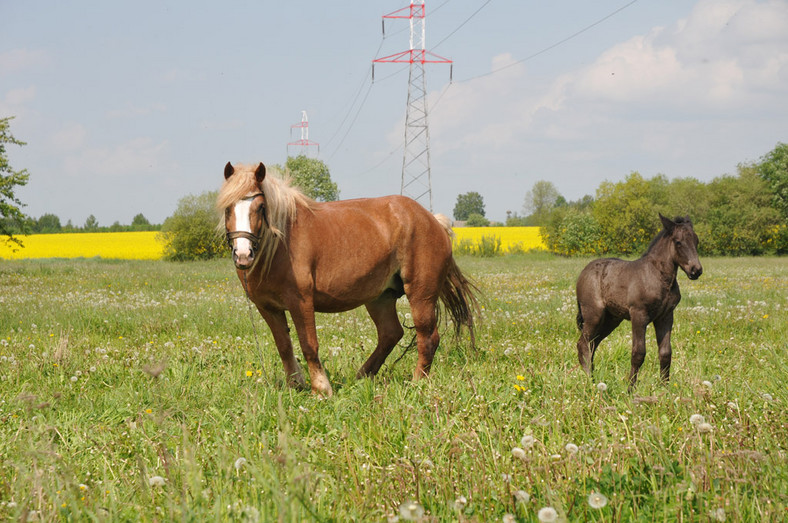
[{"x1": 435, "y1": 214, "x2": 481, "y2": 347}]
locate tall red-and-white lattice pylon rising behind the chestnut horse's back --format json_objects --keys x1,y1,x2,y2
[{"x1": 372, "y1": 0, "x2": 452, "y2": 212}]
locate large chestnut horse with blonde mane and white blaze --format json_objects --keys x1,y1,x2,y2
[{"x1": 217, "y1": 162, "x2": 478, "y2": 396}]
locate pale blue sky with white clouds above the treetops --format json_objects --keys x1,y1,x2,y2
[{"x1": 0, "y1": 0, "x2": 788, "y2": 225}]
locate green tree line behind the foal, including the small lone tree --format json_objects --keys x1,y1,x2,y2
[{"x1": 454, "y1": 143, "x2": 788, "y2": 256}]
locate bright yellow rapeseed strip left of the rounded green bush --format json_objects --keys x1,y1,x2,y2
[{"x1": 0, "y1": 231, "x2": 163, "y2": 260}]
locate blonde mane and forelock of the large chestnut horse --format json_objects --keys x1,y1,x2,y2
[{"x1": 216, "y1": 164, "x2": 314, "y2": 274}]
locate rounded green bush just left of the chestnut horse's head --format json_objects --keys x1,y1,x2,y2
[{"x1": 158, "y1": 191, "x2": 227, "y2": 261}]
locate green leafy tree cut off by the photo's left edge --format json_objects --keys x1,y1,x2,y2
[{"x1": 0, "y1": 117, "x2": 30, "y2": 247}]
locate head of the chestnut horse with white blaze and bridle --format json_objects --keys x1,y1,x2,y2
[{"x1": 222, "y1": 162, "x2": 268, "y2": 270}]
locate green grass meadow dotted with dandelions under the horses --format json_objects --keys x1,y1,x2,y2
[{"x1": 0, "y1": 254, "x2": 788, "y2": 522}]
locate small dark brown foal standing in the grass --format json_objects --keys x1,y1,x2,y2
[{"x1": 577, "y1": 214, "x2": 703, "y2": 390}]
